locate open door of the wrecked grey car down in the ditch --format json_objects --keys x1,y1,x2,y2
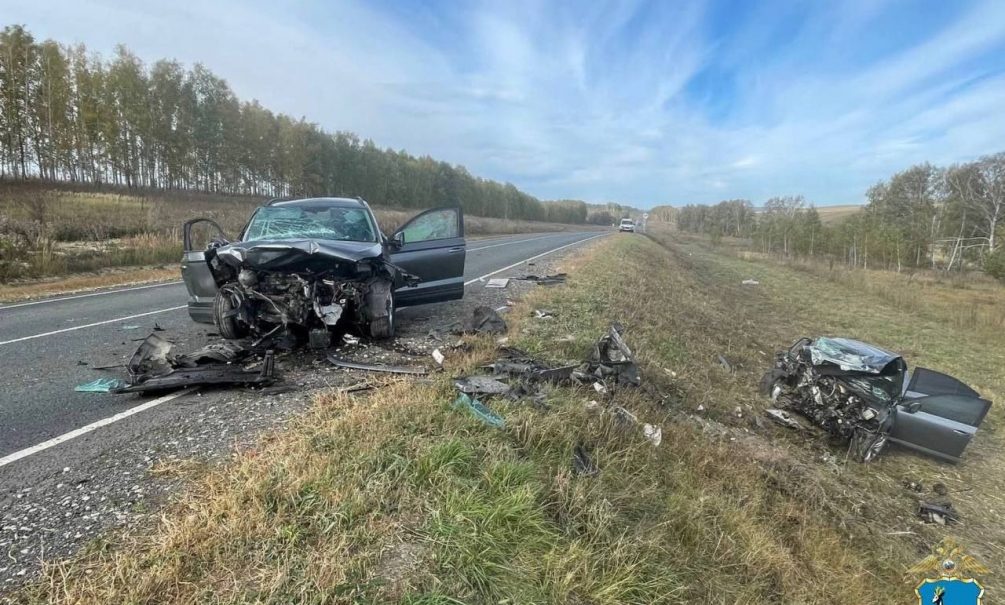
[{"x1": 889, "y1": 368, "x2": 991, "y2": 462}]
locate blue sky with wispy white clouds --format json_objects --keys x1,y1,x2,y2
[{"x1": 0, "y1": 0, "x2": 1005, "y2": 207}]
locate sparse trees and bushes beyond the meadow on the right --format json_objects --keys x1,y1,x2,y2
[{"x1": 672, "y1": 152, "x2": 1005, "y2": 278}]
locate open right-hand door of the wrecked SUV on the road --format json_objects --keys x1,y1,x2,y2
[{"x1": 390, "y1": 207, "x2": 466, "y2": 307}]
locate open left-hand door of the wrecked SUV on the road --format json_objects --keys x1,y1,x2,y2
[{"x1": 182, "y1": 218, "x2": 227, "y2": 324}]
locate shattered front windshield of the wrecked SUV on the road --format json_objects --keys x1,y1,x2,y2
[{"x1": 243, "y1": 206, "x2": 377, "y2": 241}]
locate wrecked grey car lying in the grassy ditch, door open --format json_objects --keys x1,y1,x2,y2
[{"x1": 761, "y1": 337, "x2": 991, "y2": 462}]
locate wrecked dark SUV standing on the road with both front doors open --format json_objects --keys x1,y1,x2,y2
[{"x1": 182, "y1": 198, "x2": 465, "y2": 347}]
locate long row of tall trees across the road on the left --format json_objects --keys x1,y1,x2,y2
[{"x1": 0, "y1": 25, "x2": 619, "y2": 223}]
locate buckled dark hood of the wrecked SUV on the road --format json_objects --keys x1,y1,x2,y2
[{"x1": 216, "y1": 239, "x2": 384, "y2": 271}]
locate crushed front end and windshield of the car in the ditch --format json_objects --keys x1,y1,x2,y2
[{"x1": 762, "y1": 337, "x2": 907, "y2": 462}]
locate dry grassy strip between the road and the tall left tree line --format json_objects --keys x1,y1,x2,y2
[{"x1": 0, "y1": 184, "x2": 597, "y2": 285}]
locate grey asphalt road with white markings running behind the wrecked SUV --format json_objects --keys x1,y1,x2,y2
[{"x1": 0, "y1": 231, "x2": 598, "y2": 458}]
